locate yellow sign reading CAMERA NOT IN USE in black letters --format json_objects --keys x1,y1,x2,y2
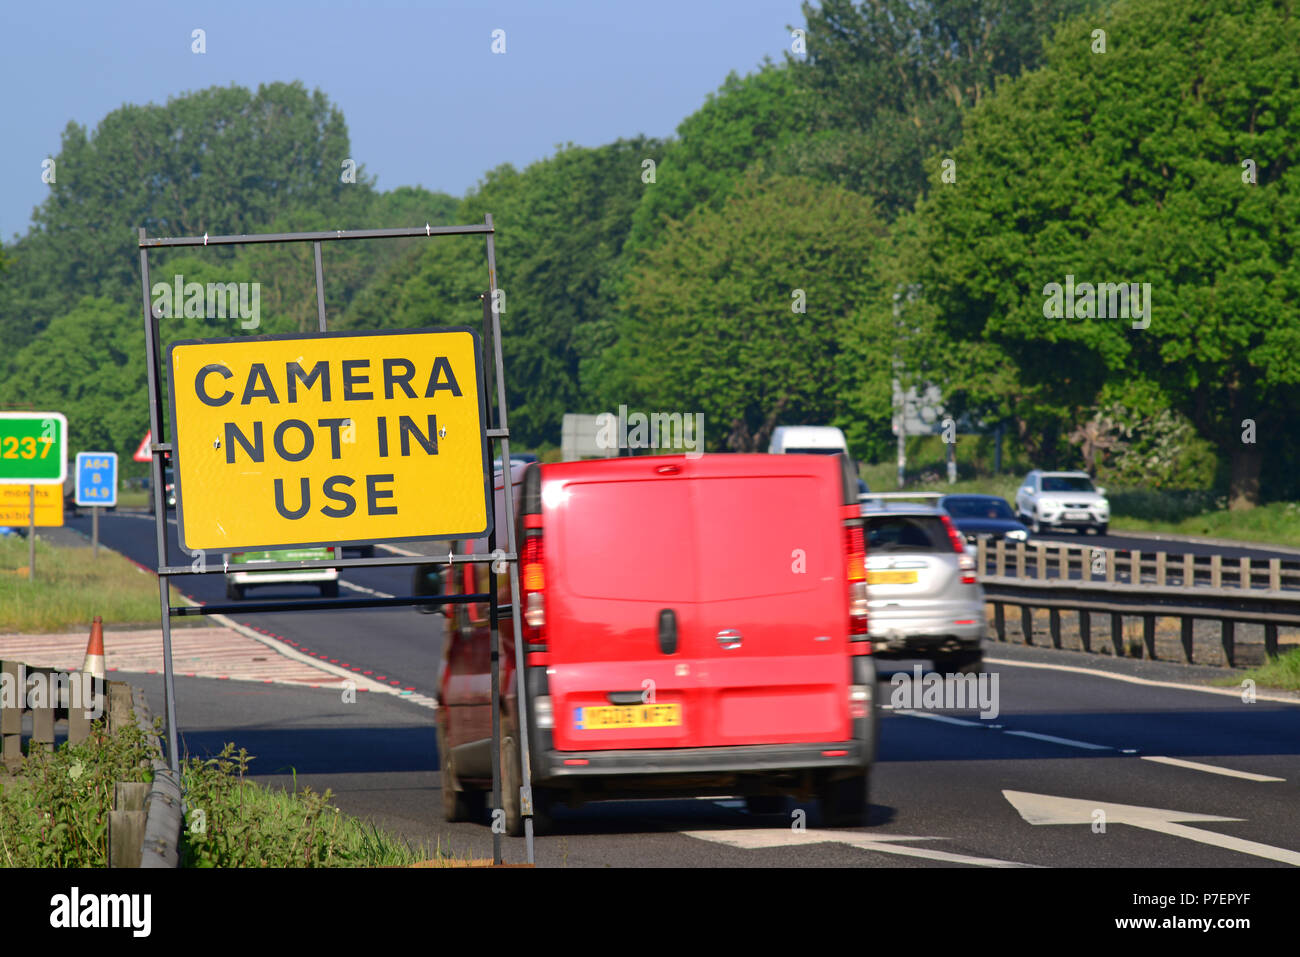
[{"x1": 168, "y1": 329, "x2": 490, "y2": 551}]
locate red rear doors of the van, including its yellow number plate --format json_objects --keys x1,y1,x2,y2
[{"x1": 542, "y1": 455, "x2": 852, "y2": 750}]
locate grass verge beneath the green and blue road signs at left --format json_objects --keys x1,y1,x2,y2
[{"x1": 0, "y1": 536, "x2": 182, "y2": 635}]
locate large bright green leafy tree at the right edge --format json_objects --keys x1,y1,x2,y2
[{"x1": 920, "y1": 0, "x2": 1300, "y2": 508}]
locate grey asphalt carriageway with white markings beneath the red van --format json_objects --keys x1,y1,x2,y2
[{"x1": 58, "y1": 515, "x2": 1300, "y2": 869}]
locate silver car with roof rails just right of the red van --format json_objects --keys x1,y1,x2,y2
[{"x1": 862, "y1": 493, "x2": 987, "y2": 674}]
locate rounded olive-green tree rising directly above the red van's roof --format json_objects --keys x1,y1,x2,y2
[{"x1": 601, "y1": 170, "x2": 889, "y2": 451}]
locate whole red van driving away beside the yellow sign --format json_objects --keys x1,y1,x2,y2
[{"x1": 431, "y1": 454, "x2": 878, "y2": 835}]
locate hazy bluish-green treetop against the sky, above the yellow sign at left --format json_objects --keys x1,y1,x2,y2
[{"x1": 0, "y1": 83, "x2": 373, "y2": 364}]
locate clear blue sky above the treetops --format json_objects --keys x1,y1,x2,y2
[{"x1": 0, "y1": 0, "x2": 803, "y2": 242}]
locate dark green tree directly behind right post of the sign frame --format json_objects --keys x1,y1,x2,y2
[{"x1": 345, "y1": 138, "x2": 662, "y2": 447}]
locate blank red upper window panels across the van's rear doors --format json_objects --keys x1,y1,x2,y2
[{"x1": 561, "y1": 476, "x2": 842, "y2": 602}]
